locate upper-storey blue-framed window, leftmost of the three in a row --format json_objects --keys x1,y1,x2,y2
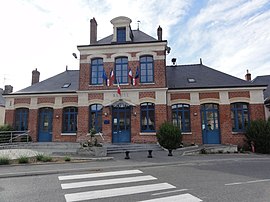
[{"x1": 91, "y1": 58, "x2": 104, "y2": 85}]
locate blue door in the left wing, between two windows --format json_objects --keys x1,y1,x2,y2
[{"x1": 38, "y1": 108, "x2": 53, "y2": 142}]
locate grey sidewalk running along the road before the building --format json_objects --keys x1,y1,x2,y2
[{"x1": 0, "y1": 148, "x2": 270, "y2": 178}]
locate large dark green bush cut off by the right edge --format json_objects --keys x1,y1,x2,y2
[{"x1": 245, "y1": 119, "x2": 270, "y2": 154}]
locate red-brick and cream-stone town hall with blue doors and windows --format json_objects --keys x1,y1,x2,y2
[{"x1": 5, "y1": 16, "x2": 266, "y2": 145}]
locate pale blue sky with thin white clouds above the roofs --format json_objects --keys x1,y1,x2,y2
[{"x1": 0, "y1": 0, "x2": 270, "y2": 91}]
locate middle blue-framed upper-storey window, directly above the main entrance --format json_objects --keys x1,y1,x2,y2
[{"x1": 115, "y1": 57, "x2": 128, "y2": 84}]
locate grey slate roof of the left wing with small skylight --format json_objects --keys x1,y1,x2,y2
[{"x1": 12, "y1": 70, "x2": 79, "y2": 95}]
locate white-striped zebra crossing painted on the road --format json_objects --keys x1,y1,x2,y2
[{"x1": 58, "y1": 170, "x2": 202, "y2": 202}]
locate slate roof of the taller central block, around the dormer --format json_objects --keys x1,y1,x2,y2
[{"x1": 78, "y1": 30, "x2": 158, "y2": 47}]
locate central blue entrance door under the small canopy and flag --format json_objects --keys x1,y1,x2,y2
[{"x1": 112, "y1": 103, "x2": 131, "y2": 143}]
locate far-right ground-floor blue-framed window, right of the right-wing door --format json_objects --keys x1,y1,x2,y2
[{"x1": 231, "y1": 102, "x2": 250, "y2": 132}]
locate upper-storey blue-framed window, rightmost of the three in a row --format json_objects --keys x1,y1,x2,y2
[{"x1": 140, "y1": 56, "x2": 154, "y2": 83}]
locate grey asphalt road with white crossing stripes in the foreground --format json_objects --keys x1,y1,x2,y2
[{"x1": 0, "y1": 155, "x2": 270, "y2": 202}]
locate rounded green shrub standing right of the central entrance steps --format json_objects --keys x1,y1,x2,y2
[{"x1": 157, "y1": 122, "x2": 182, "y2": 150}]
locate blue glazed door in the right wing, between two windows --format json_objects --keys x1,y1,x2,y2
[{"x1": 201, "y1": 104, "x2": 220, "y2": 144}]
